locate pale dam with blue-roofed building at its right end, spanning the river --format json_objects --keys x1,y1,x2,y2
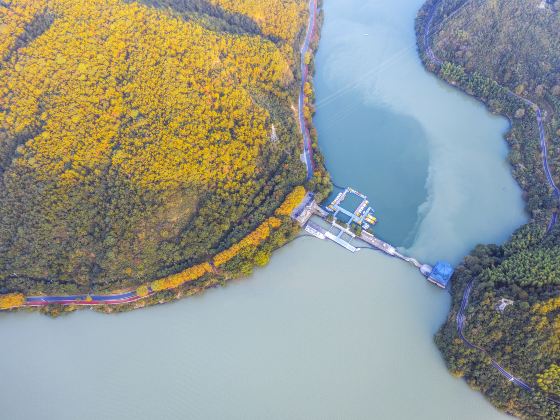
[{"x1": 292, "y1": 187, "x2": 453, "y2": 289}]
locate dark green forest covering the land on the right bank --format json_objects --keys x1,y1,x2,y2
[{"x1": 417, "y1": 0, "x2": 560, "y2": 418}]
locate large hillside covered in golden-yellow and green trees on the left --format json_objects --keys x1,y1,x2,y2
[{"x1": 0, "y1": 0, "x2": 307, "y2": 293}]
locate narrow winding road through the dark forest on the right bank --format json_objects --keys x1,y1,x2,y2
[{"x1": 424, "y1": 0, "x2": 560, "y2": 404}]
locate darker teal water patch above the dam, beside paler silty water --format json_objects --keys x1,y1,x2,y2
[{"x1": 315, "y1": 92, "x2": 429, "y2": 247}]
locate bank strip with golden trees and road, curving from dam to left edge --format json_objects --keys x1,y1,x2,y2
[{"x1": 0, "y1": 186, "x2": 306, "y2": 316}]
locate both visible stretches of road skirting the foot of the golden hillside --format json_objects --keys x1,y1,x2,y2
[{"x1": 1, "y1": 0, "x2": 317, "y2": 307}]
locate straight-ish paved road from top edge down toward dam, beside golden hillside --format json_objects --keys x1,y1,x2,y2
[{"x1": 298, "y1": 0, "x2": 317, "y2": 180}]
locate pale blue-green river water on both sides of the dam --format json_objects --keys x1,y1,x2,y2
[{"x1": 0, "y1": 0, "x2": 525, "y2": 420}]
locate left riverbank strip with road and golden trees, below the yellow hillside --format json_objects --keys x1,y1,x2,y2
[{"x1": 0, "y1": 0, "x2": 332, "y2": 316}]
